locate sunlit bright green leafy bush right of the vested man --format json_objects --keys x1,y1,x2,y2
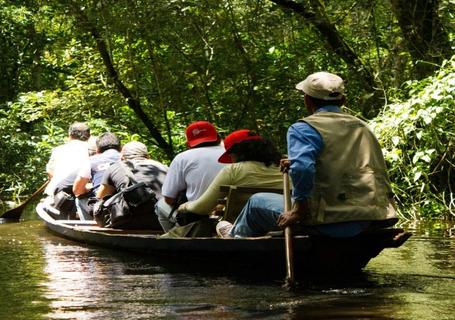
[{"x1": 370, "y1": 57, "x2": 455, "y2": 218}]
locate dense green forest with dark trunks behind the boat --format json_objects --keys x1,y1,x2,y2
[{"x1": 0, "y1": 0, "x2": 455, "y2": 219}]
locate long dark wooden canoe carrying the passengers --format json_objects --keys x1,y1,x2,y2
[{"x1": 36, "y1": 203, "x2": 411, "y2": 276}]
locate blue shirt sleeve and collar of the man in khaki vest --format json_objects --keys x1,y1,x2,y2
[{"x1": 287, "y1": 106, "x2": 341, "y2": 201}]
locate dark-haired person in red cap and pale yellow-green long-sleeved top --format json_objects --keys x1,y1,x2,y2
[{"x1": 178, "y1": 129, "x2": 283, "y2": 229}]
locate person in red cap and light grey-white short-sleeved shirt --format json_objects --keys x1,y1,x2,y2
[{"x1": 155, "y1": 121, "x2": 224, "y2": 232}]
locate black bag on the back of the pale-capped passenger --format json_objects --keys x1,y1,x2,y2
[{"x1": 94, "y1": 162, "x2": 161, "y2": 230}]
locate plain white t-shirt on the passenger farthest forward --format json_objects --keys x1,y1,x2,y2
[{"x1": 44, "y1": 140, "x2": 88, "y2": 195}]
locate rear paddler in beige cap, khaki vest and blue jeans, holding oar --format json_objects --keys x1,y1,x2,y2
[{"x1": 217, "y1": 72, "x2": 397, "y2": 237}]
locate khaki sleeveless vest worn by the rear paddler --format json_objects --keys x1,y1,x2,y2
[{"x1": 301, "y1": 112, "x2": 396, "y2": 225}]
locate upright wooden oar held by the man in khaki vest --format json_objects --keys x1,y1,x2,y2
[{"x1": 283, "y1": 171, "x2": 295, "y2": 288}]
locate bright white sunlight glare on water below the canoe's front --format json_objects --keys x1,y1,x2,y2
[{"x1": 38, "y1": 239, "x2": 171, "y2": 319}]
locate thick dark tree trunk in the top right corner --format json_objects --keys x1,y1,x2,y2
[{"x1": 390, "y1": 0, "x2": 453, "y2": 79}]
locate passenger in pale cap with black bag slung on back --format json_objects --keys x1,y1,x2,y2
[{"x1": 96, "y1": 141, "x2": 168, "y2": 230}]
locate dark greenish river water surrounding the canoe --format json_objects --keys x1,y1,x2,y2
[{"x1": 0, "y1": 204, "x2": 455, "y2": 320}]
